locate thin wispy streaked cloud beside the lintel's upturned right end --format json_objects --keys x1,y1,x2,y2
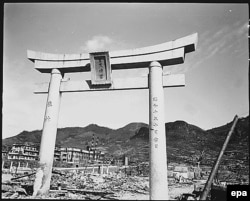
[{"x1": 184, "y1": 21, "x2": 248, "y2": 72}]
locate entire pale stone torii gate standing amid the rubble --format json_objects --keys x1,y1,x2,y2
[{"x1": 27, "y1": 33, "x2": 198, "y2": 200}]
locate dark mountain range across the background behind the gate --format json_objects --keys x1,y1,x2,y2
[{"x1": 2, "y1": 116, "x2": 249, "y2": 169}]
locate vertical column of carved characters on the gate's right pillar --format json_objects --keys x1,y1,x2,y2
[{"x1": 152, "y1": 97, "x2": 159, "y2": 148}]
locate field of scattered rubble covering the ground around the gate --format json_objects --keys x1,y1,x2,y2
[{"x1": 2, "y1": 164, "x2": 249, "y2": 200}]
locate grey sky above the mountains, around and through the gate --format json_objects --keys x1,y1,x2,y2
[{"x1": 2, "y1": 3, "x2": 249, "y2": 139}]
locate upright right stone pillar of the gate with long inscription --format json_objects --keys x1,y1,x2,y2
[{"x1": 149, "y1": 61, "x2": 168, "y2": 200}]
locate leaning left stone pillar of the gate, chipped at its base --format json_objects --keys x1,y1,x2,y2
[{"x1": 33, "y1": 69, "x2": 63, "y2": 196}]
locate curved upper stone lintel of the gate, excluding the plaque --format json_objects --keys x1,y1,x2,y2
[{"x1": 27, "y1": 33, "x2": 198, "y2": 73}]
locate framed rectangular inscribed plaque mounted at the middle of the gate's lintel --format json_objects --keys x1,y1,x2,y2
[{"x1": 89, "y1": 52, "x2": 111, "y2": 85}]
